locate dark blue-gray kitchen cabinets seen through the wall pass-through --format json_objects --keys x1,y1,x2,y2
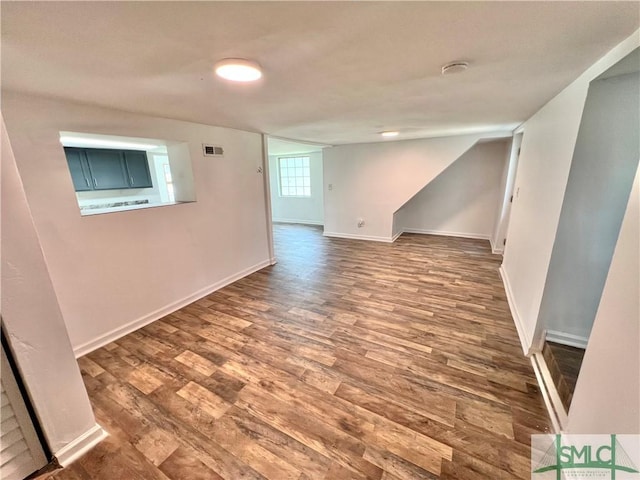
[{"x1": 64, "y1": 147, "x2": 153, "y2": 192}]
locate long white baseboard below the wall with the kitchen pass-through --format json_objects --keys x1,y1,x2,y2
[{"x1": 73, "y1": 259, "x2": 275, "y2": 358}]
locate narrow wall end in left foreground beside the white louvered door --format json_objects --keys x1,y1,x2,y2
[{"x1": 1, "y1": 115, "x2": 95, "y2": 455}]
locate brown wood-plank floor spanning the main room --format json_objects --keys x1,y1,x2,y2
[{"x1": 54, "y1": 225, "x2": 548, "y2": 480}]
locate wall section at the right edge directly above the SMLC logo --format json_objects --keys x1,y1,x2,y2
[{"x1": 567, "y1": 165, "x2": 640, "y2": 434}]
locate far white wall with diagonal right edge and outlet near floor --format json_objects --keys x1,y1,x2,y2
[{"x1": 323, "y1": 135, "x2": 492, "y2": 242}]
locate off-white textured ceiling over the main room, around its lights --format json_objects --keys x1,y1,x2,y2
[{"x1": 0, "y1": 1, "x2": 640, "y2": 144}]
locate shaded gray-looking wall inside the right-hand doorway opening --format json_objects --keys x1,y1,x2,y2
[{"x1": 538, "y1": 69, "x2": 640, "y2": 346}]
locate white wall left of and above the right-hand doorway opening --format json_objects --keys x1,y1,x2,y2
[{"x1": 501, "y1": 32, "x2": 640, "y2": 352}]
